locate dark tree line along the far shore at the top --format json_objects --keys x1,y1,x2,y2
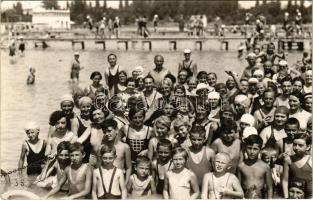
[{"x1": 1, "y1": 0, "x2": 312, "y2": 24}]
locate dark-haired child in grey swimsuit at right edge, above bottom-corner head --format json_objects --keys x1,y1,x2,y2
[{"x1": 282, "y1": 134, "x2": 312, "y2": 199}]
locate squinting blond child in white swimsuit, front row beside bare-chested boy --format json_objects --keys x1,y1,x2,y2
[{"x1": 201, "y1": 153, "x2": 243, "y2": 199}]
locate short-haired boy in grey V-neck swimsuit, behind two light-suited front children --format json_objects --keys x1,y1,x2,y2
[{"x1": 186, "y1": 126, "x2": 215, "y2": 187}]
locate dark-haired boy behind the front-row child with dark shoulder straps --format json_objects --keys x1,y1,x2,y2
[{"x1": 102, "y1": 119, "x2": 132, "y2": 183}]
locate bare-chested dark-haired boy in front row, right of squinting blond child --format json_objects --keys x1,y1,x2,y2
[{"x1": 238, "y1": 135, "x2": 273, "y2": 199}]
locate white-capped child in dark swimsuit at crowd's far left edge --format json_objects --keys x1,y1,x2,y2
[{"x1": 18, "y1": 122, "x2": 46, "y2": 175}]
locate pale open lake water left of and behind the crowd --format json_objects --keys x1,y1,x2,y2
[{"x1": 1, "y1": 43, "x2": 302, "y2": 197}]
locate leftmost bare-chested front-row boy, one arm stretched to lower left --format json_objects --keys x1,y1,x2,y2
[{"x1": 44, "y1": 142, "x2": 92, "y2": 199}]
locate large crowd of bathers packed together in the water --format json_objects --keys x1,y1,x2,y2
[{"x1": 11, "y1": 37, "x2": 312, "y2": 199}]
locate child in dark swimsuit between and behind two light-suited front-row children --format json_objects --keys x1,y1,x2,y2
[{"x1": 152, "y1": 139, "x2": 173, "y2": 194}]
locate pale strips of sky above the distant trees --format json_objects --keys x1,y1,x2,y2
[{"x1": 1, "y1": 0, "x2": 311, "y2": 9}]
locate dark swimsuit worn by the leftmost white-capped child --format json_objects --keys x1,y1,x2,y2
[{"x1": 25, "y1": 141, "x2": 46, "y2": 175}]
